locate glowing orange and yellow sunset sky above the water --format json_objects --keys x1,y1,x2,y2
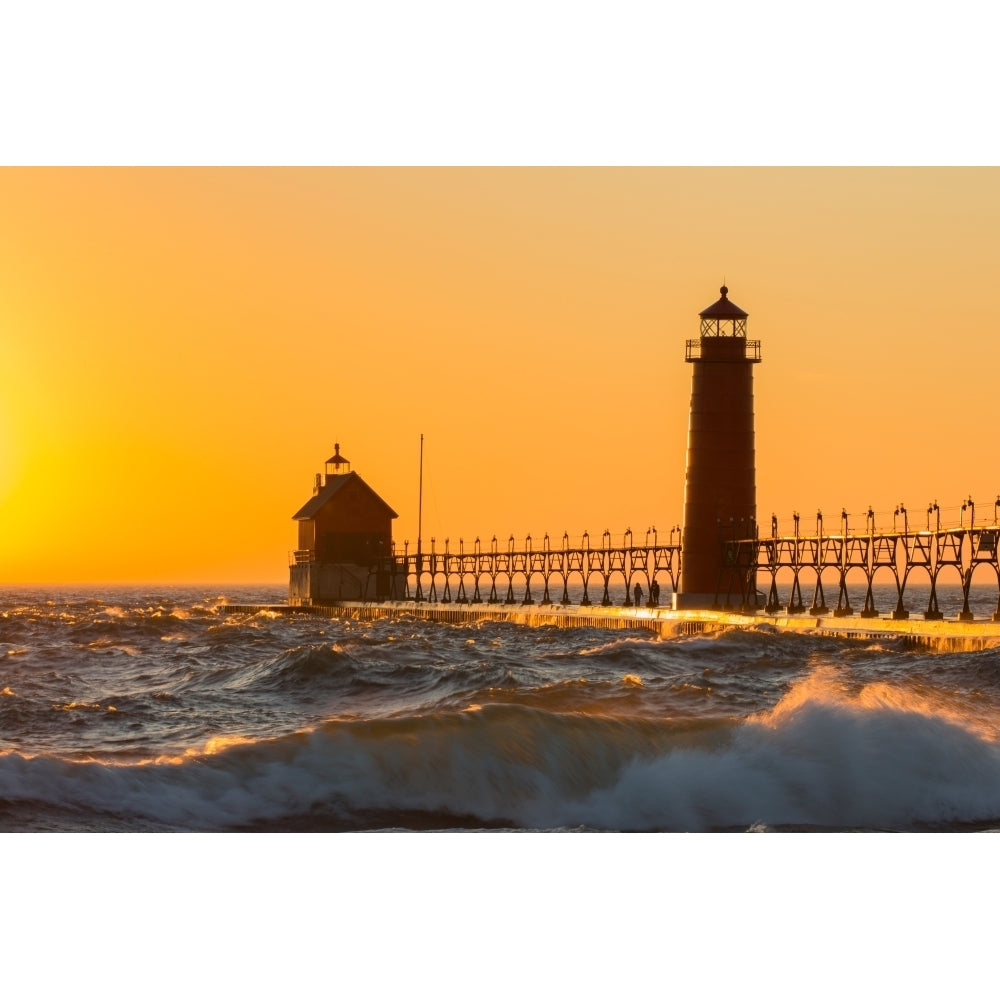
[{"x1": 0, "y1": 167, "x2": 1000, "y2": 583}]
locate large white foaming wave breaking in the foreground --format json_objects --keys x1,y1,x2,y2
[{"x1": 7, "y1": 659, "x2": 1000, "y2": 831}]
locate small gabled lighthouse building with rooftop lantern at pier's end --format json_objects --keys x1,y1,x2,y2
[{"x1": 288, "y1": 444, "x2": 398, "y2": 606}]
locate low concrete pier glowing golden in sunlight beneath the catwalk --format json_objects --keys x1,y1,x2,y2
[{"x1": 219, "y1": 601, "x2": 1000, "y2": 650}]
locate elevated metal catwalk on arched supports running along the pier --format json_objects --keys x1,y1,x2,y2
[{"x1": 342, "y1": 498, "x2": 1000, "y2": 621}]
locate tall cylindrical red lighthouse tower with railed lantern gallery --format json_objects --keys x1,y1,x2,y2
[{"x1": 676, "y1": 285, "x2": 760, "y2": 608}]
